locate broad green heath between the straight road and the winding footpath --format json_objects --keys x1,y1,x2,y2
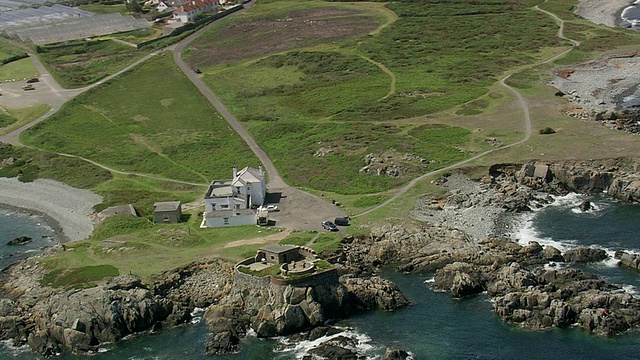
[{"x1": 188, "y1": 1, "x2": 564, "y2": 194}]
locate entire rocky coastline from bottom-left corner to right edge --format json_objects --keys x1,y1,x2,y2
[{"x1": 0, "y1": 159, "x2": 640, "y2": 359}]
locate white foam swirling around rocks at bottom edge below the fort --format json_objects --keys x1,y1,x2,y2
[{"x1": 277, "y1": 327, "x2": 383, "y2": 360}]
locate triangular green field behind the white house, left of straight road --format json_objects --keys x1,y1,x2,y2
[{"x1": 22, "y1": 54, "x2": 258, "y2": 184}]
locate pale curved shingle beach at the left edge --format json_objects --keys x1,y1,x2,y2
[{"x1": 0, "y1": 178, "x2": 102, "y2": 241}]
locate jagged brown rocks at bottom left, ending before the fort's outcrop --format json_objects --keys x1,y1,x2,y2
[{"x1": 0, "y1": 255, "x2": 234, "y2": 356}]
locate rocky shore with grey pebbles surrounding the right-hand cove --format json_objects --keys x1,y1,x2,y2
[{"x1": 334, "y1": 159, "x2": 640, "y2": 336}]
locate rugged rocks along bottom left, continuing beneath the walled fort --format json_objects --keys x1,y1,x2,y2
[{"x1": 0, "y1": 245, "x2": 409, "y2": 359}]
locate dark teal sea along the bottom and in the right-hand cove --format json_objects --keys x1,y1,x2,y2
[{"x1": 0, "y1": 195, "x2": 640, "y2": 360}]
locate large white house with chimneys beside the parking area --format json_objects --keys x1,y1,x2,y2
[{"x1": 203, "y1": 166, "x2": 267, "y2": 227}]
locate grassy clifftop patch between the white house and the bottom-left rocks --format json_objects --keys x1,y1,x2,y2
[{"x1": 37, "y1": 215, "x2": 282, "y2": 286}]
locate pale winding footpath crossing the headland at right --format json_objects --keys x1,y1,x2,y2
[{"x1": 352, "y1": 5, "x2": 580, "y2": 218}]
